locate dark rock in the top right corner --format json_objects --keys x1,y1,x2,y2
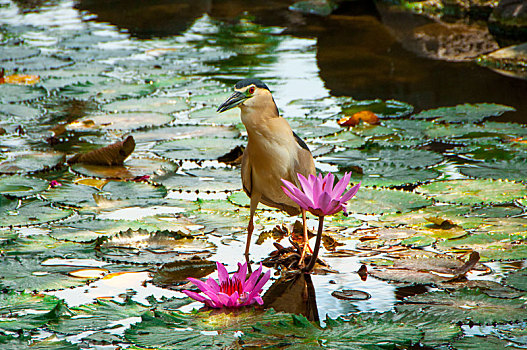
[{"x1": 489, "y1": 0, "x2": 527, "y2": 42}]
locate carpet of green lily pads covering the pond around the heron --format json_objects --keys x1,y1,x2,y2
[{"x1": 0, "y1": 2, "x2": 527, "y2": 349}]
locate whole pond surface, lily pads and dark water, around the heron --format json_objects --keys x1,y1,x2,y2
[{"x1": 0, "y1": 0, "x2": 527, "y2": 349}]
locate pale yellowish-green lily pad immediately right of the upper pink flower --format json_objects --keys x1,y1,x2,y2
[{"x1": 347, "y1": 187, "x2": 432, "y2": 214}]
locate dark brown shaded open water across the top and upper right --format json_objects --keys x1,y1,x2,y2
[{"x1": 76, "y1": 0, "x2": 527, "y2": 123}]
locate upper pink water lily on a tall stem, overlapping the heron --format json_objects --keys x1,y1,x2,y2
[{"x1": 282, "y1": 173, "x2": 360, "y2": 217}]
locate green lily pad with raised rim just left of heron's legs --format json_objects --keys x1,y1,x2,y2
[{"x1": 98, "y1": 229, "x2": 215, "y2": 265}]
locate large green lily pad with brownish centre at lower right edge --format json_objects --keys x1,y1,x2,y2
[{"x1": 396, "y1": 288, "x2": 527, "y2": 325}]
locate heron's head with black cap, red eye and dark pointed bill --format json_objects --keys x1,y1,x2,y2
[{"x1": 217, "y1": 79, "x2": 276, "y2": 113}]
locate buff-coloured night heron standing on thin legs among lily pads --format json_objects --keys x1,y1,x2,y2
[{"x1": 218, "y1": 79, "x2": 316, "y2": 262}]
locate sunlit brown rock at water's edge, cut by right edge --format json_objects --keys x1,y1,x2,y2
[{"x1": 477, "y1": 43, "x2": 527, "y2": 79}]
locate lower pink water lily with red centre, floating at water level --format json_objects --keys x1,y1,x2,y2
[{"x1": 183, "y1": 262, "x2": 271, "y2": 309}]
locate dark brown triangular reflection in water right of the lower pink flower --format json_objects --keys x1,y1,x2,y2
[{"x1": 263, "y1": 273, "x2": 319, "y2": 322}]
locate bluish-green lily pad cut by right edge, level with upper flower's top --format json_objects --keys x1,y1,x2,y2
[{"x1": 458, "y1": 157, "x2": 527, "y2": 181}]
